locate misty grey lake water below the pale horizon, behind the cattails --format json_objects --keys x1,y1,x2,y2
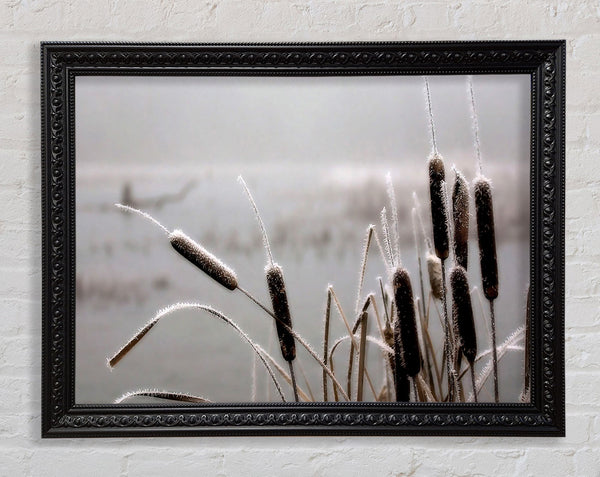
[{"x1": 75, "y1": 163, "x2": 529, "y2": 403}]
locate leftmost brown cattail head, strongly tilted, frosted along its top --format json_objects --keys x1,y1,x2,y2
[{"x1": 169, "y1": 230, "x2": 238, "y2": 290}]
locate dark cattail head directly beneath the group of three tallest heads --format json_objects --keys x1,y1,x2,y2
[{"x1": 450, "y1": 265, "x2": 477, "y2": 364}]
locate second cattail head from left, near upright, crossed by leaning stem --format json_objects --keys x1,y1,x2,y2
[{"x1": 265, "y1": 263, "x2": 296, "y2": 361}]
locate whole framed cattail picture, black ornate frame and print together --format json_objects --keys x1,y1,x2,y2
[{"x1": 41, "y1": 41, "x2": 565, "y2": 437}]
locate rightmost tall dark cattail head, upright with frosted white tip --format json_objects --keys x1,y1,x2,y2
[{"x1": 473, "y1": 176, "x2": 498, "y2": 300}]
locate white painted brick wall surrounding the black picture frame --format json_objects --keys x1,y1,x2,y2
[{"x1": 0, "y1": 0, "x2": 600, "y2": 476}]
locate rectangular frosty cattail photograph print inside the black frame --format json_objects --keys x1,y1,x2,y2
[{"x1": 75, "y1": 74, "x2": 531, "y2": 406}]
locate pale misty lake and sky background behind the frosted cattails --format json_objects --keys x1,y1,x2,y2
[{"x1": 76, "y1": 75, "x2": 530, "y2": 403}]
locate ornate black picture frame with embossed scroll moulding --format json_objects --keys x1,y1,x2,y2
[{"x1": 41, "y1": 41, "x2": 565, "y2": 437}]
